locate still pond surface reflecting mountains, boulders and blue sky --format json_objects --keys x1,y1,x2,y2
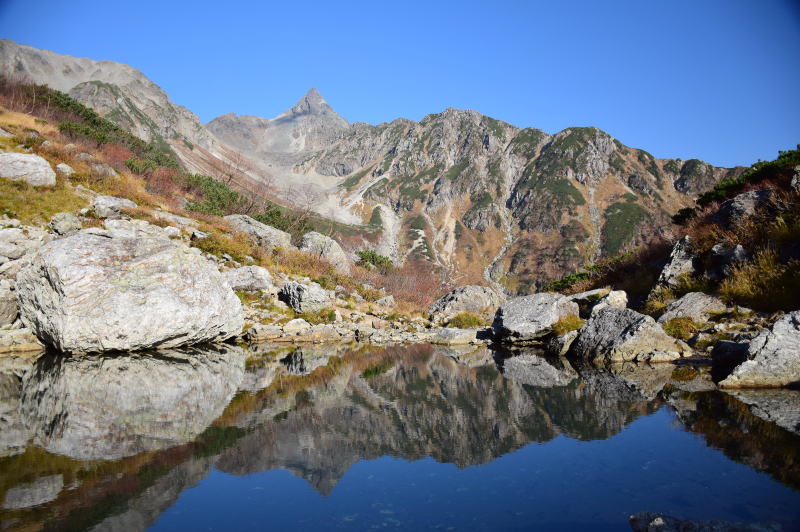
[{"x1": 0, "y1": 345, "x2": 800, "y2": 530}]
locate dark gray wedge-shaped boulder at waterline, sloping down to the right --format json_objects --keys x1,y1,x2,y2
[{"x1": 570, "y1": 307, "x2": 691, "y2": 362}]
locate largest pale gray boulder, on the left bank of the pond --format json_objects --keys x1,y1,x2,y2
[{"x1": 16, "y1": 220, "x2": 244, "y2": 353}]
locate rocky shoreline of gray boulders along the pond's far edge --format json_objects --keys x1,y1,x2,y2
[{"x1": 0, "y1": 189, "x2": 800, "y2": 388}]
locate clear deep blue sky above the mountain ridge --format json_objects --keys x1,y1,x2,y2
[{"x1": 0, "y1": 0, "x2": 800, "y2": 165}]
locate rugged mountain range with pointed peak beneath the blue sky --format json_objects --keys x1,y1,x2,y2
[{"x1": 0, "y1": 40, "x2": 744, "y2": 292}]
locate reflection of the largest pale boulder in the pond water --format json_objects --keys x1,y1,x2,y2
[{"x1": 22, "y1": 345, "x2": 244, "y2": 460}]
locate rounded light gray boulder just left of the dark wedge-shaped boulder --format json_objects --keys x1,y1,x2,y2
[{"x1": 492, "y1": 292, "x2": 579, "y2": 342}]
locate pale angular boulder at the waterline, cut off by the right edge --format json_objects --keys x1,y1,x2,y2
[{"x1": 719, "y1": 311, "x2": 800, "y2": 388}]
